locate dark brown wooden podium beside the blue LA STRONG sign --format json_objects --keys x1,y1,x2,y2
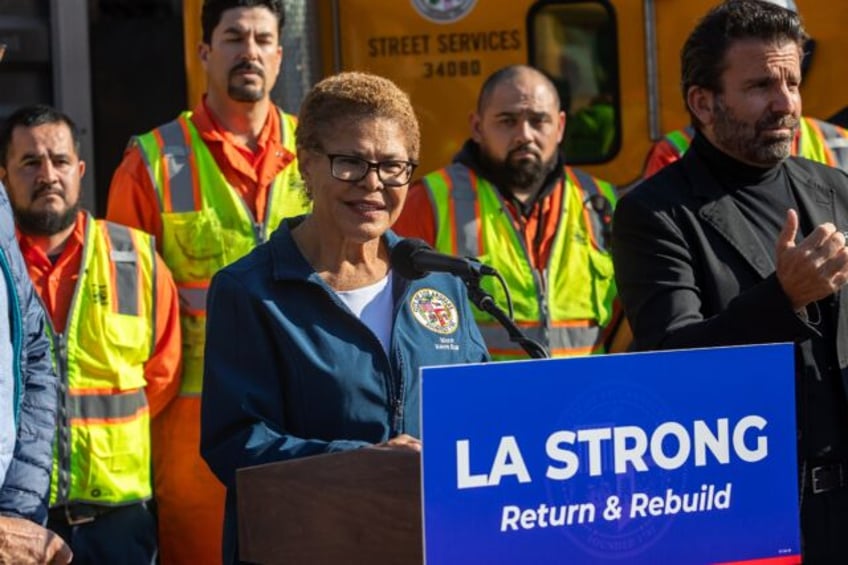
[{"x1": 236, "y1": 448, "x2": 423, "y2": 565}]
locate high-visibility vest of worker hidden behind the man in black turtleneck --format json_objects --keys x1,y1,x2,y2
[{"x1": 663, "y1": 116, "x2": 848, "y2": 171}]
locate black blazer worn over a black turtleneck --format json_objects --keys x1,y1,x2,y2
[{"x1": 612, "y1": 145, "x2": 848, "y2": 378}]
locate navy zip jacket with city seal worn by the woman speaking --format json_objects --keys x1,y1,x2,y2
[{"x1": 200, "y1": 219, "x2": 488, "y2": 563}]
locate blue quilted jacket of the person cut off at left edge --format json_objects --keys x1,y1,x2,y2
[{"x1": 0, "y1": 184, "x2": 58, "y2": 523}]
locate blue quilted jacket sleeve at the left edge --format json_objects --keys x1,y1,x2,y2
[{"x1": 0, "y1": 227, "x2": 58, "y2": 523}]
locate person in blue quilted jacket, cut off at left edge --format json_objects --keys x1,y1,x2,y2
[{"x1": 0, "y1": 38, "x2": 72, "y2": 565}]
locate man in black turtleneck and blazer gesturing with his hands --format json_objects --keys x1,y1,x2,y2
[{"x1": 613, "y1": 0, "x2": 848, "y2": 564}]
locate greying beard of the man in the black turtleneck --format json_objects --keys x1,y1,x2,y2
[{"x1": 713, "y1": 96, "x2": 798, "y2": 167}]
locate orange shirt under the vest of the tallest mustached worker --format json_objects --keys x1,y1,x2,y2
[{"x1": 106, "y1": 101, "x2": 295, "y2": 241}]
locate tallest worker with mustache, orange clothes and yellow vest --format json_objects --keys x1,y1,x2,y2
[{"x1": 106, "y1": 0, "x2": 308, "y2": 565}]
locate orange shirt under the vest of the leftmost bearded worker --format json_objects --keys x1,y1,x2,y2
[{"x1": 18, "y1": 212, "x2": 182, "y2": 417}]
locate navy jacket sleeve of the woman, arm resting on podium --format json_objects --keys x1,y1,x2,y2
[{"x1": 200, "y1": 271, "x2": 370, "y2": 488}]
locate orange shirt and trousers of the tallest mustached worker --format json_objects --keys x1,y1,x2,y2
[{"x1": 106, "y1": 97, "x2": 295, "y2": 564}]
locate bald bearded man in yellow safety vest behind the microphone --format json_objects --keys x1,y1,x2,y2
[{"x1": 394, "y1": 65, "x2": 627, "y2": 360}]
